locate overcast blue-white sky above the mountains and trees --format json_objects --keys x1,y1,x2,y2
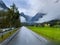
[{"x1": 3, "y1": 0, "x2": 60, "y2": 22}]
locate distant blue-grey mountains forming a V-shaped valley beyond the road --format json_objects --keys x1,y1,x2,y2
[{"x1": 20, "y1": 12, "x2": 46, "y2": 24}]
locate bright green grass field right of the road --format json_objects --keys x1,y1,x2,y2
[{"x1": 28, "y1": 26, "x2": 60, "y2": 41}]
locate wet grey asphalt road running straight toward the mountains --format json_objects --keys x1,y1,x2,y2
[{"x1": 7, "y1": 26, "x2": 48, "y2": 45}]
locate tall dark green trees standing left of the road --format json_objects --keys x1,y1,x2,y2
[{"x1": 0, "y1": 3, "x2": 21, "y2": 28}]
